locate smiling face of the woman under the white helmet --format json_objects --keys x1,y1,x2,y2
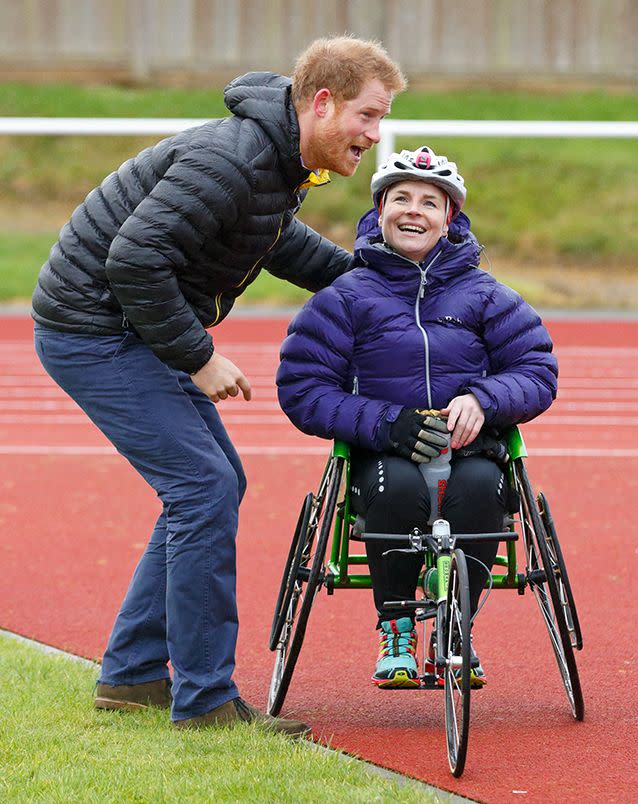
[{"x1": 379, "y1": 181, "x2": 448, "y2": 262}]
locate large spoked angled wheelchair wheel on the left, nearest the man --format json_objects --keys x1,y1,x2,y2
[{"x1": 267, "y1": 457, "x2": 344, "y2": 715}]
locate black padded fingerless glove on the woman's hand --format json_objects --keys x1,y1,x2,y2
[{"x1": 390, "y1": 408, "x2": 450, "y2": 463}]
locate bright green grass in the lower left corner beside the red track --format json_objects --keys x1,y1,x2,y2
[{"x1": 0, "y1": 635, "x2": 436, "y2": 804}]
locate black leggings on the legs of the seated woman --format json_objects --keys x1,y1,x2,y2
[{"x1": 350, "y1": 452, "x2": 507, "y2": 627}]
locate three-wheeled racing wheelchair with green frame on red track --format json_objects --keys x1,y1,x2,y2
[{"x1": 268, "y1": 427, "x2": 584, "y2": 776}]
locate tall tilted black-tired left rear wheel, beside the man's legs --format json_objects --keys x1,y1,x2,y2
[{"x1": 267, "y1": 457, "x2": 344, "y2": 715}]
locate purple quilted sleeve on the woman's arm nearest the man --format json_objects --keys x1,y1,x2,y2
[{"x1": 277, "y1": 287, "x2": 401, "y2": 451}]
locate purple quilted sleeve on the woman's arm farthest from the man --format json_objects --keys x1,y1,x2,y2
[{"x1": 466, "y1": 284, "x2": 558, "y2": 428}]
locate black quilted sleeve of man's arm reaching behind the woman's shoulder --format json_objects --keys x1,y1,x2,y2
[{"x1": 267, "y1": 218, "x2": 354, "y2": 291}]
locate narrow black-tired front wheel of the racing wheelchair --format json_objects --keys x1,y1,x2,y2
[{"x1": 440, "y1": 549, "x2": 472, "y2": 777}]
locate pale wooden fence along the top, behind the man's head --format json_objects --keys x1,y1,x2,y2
[{"x1": 0, "y1": 0, "x2": 638, "y2": 82}]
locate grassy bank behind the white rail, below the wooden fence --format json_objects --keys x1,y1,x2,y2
[{"x1": 0, "y1": 84, "x2": 638, "y2": 303}]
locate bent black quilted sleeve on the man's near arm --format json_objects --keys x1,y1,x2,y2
[{"x1": 106, "y1": 149, "x2": 250, "y2": 373}]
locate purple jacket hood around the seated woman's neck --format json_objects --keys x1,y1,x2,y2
[{"x1": 354, "y1": 208, "x2": 481, "y2": 281}]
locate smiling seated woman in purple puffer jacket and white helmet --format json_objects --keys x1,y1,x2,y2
[{"x1": 277, "y1": 146, "x2": 558, "y2": 687}]
